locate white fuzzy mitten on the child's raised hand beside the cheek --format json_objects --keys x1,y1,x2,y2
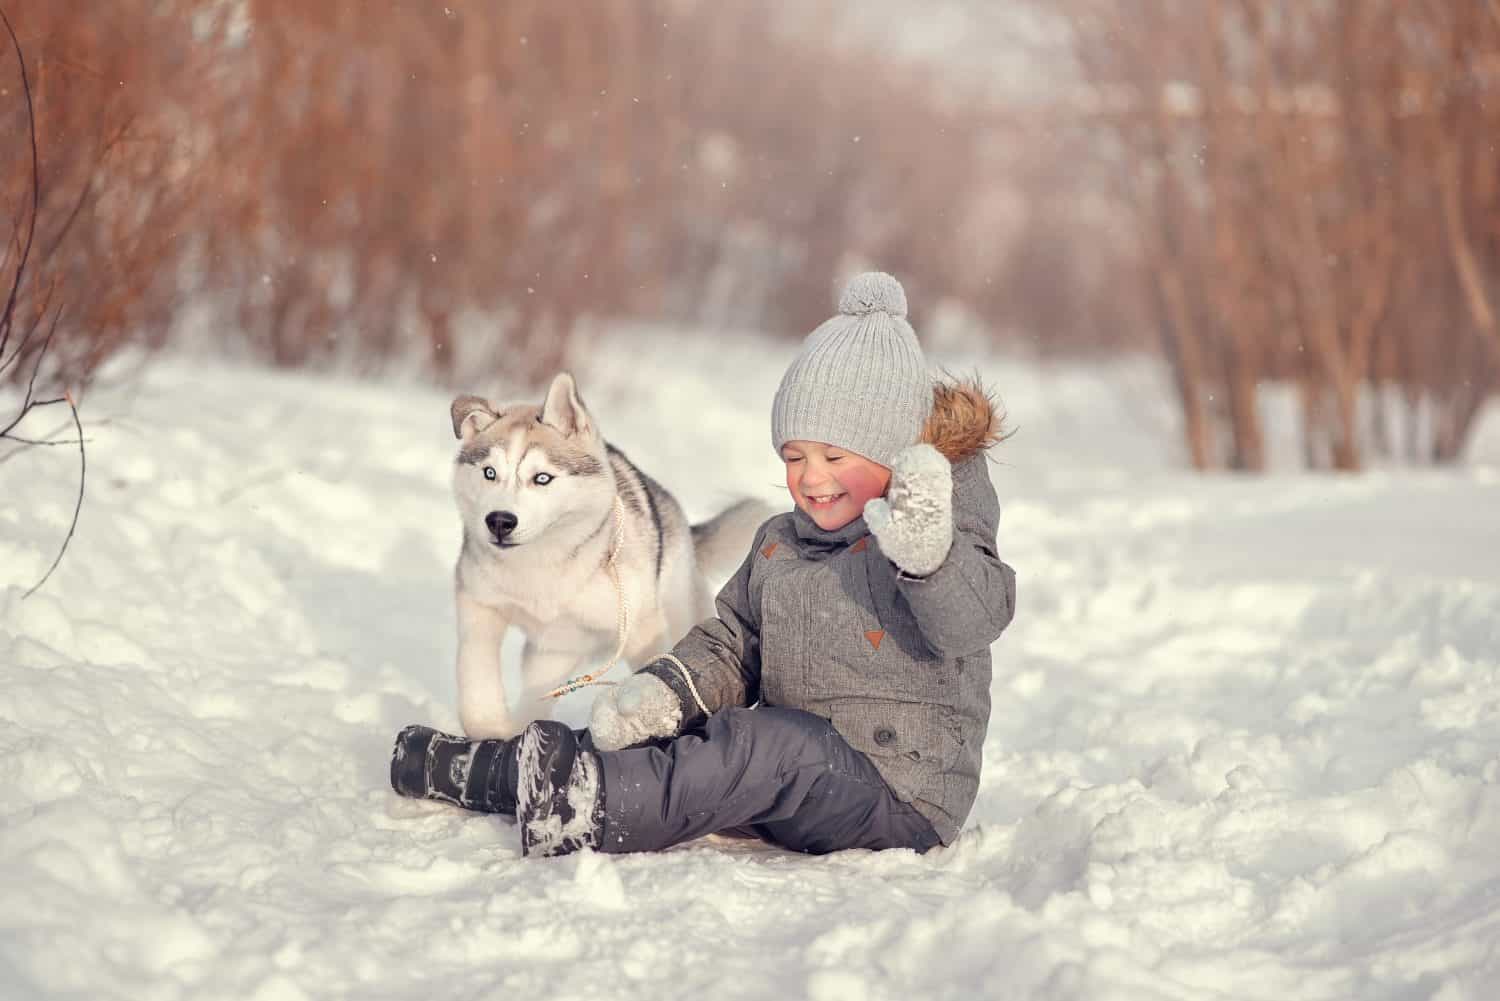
[{"x1": 864, "y1": 444, "x2": 953, "y2": 576}]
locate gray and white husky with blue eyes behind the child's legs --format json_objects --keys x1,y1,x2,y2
[{"x1": 452, "y1": 372, "x2": 774, "y2": 738}]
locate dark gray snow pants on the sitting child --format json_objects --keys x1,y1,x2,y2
[{"x1": 582, "y1": 707, "x2": 939, "y2": 854}]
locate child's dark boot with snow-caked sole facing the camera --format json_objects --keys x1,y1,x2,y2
[{"x1": 516, "y1": 719, "x2": 602, "y2": 857}]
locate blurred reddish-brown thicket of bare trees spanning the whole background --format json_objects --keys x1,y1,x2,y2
[{"x1": 0, "y1": 0, "x2": 1500, "y2": 470}]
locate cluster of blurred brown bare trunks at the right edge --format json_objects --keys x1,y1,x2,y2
[{"x1": 1062, "y1": 0, "x2": 1500, "y2": 470}]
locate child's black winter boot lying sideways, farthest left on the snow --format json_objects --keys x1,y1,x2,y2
[{"x1": 390, "y1": 725, "x2": 521, "y2": 813}]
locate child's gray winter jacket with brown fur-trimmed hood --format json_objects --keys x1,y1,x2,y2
[{"x1": 663, "y1": 386, "x2": 1016, "y2": 843}]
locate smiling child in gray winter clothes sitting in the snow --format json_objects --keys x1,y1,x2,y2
[{"x1": 392, "y1": 273, "x2": 1016, "y2": 855}]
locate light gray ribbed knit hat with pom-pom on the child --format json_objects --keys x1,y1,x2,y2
[{"x1": 771, "y1": 272, "x2": 933, "y2": 465}]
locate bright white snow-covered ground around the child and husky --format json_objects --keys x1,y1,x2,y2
[{"x1": 0, "y1": 333, "x2": 1500, "y2": 1001}]
